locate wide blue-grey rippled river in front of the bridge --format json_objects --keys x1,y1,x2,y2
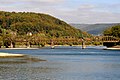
[{"x1": 0, "y1": 46, "x2": 120, "y2": 80}]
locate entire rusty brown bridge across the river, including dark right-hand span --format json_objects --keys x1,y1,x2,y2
[{"x1": 8, "y1": 36, "x2": 120, "y2": 49}]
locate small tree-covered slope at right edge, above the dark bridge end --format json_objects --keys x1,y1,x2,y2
[{"x1": 103, "y1": 24, "x2": 120, "y2": 38}]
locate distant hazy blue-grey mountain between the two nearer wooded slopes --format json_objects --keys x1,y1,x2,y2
[{"x1": 70, "y1": 23, "x2": 119, "y2": 35}]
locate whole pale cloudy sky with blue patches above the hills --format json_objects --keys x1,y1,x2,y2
[{"x1": 0, "y1": 0, "x2": 120, "y2": 24}]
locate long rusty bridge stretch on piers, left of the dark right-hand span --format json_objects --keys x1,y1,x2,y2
[{"x1": 11, "y1": 37, "x2": 90, "y2": 48}]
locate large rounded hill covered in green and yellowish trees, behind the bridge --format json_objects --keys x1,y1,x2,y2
[{"x1": 0, "y1": 11, "x2": 90, "y2": 37}]
